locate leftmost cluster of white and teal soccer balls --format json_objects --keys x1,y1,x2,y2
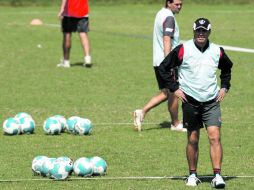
[{"x1": 3, "y1": 112, "x2": 35, "y2": 135}]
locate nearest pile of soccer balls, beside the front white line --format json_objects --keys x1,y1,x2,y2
[{"x1": 32, "y1": 156, "x2": 107, "y2": 180}]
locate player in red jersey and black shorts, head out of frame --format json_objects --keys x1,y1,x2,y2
[{"x1": 57, "y1": 0, "x2": 91, "y2": 68}]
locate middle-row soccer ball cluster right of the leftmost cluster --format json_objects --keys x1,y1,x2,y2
[{"x1": 43, "y1": 115, "x2": 92, "y2": 135}]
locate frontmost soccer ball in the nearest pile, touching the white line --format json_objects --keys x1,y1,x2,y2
[{"x1": 49, "y1": 160, "x2": 69, "y2": 180}]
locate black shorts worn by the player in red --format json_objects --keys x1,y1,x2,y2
[{"x1": 62, "y1": 17, "x2": 89, "y2": 33}]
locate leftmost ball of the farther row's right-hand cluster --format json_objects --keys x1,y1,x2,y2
[{"x1": 43, "y1": 117, "x2": 62, "y2": 135}]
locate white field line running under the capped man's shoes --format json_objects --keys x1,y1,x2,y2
[{"x1": 0, "y1": 175, "x2": 254, "y2": 183}]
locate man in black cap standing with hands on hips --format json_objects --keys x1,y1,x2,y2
[{"x1": 159, "y1": 18, "x2": 233, "y2": 188}]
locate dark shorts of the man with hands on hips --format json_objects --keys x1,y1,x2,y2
[{"x1": 182, "y1": 94, "x2": 221, "y2": 131}]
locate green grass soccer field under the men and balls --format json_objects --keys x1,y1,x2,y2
[{"x1": 0, "y1": 2, "x2": 254, "y2": 190}]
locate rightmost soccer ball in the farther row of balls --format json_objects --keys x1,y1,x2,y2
[{"x1": 74, "y1": 118, "x2": 92, "y2": 135}]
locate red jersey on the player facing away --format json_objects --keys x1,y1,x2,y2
[{"x1": 63, "y1": 0, "x2": 89, "y2": 18}]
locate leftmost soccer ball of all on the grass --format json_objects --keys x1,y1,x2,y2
[{"x1": 3, "y1": 117, "x2": 21, "y2": 135}]
